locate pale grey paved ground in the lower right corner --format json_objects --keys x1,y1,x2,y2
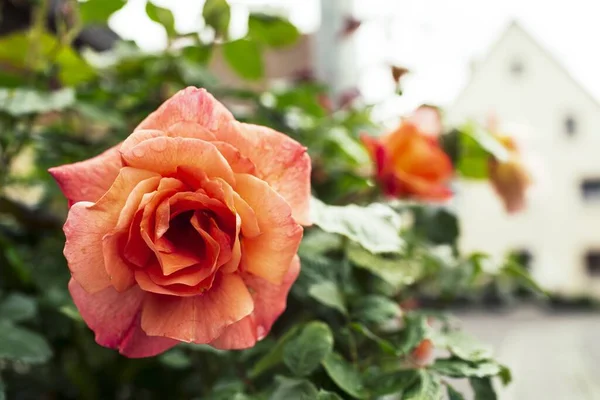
[{"x1": 455, "y1": 307, "x2": 600, "y2": 400}]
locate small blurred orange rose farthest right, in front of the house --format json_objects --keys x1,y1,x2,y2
[{"x1": 489, "y1": 135, "x2": 531, "y2": 214}]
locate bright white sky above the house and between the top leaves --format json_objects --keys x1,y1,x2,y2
[{"x1": 111, "y1": 0, "x2": 600, "y2": 121}]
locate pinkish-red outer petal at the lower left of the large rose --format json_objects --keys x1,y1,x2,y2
[{"x1": 69, "y1": 279, "x2": 178, "y2": 358}]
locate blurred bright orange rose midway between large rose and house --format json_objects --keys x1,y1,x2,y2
[{"x1": 361, "y1": 121, "x2": 452, "y2": 200}]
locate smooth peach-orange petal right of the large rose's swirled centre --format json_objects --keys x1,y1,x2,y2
[{"x1": 236, "y1": 174, "x2": 302, "y2": 284}]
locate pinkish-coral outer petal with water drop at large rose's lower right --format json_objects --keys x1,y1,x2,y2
[{"x1": 211, "y1": 256, "x2": 300, "y2": 350}]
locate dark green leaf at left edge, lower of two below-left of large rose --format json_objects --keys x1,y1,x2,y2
[{"x1": 0, "y1": 323, "x2": 52, "y2": 364}]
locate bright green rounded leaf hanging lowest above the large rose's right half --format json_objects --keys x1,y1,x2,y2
[{"x1": 223, "y1": 39, "x2": 264, "y2": 80}]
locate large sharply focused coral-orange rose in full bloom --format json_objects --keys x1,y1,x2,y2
[{"x1": 50, "y1": 88, "x2": 310, "y2": 357}]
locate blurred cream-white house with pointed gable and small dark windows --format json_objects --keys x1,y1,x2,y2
[{"x1": 448, "y1": 23, "x2": 600, "y2": 297}]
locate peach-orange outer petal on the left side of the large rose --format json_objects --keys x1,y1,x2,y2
[{"x1": 63, "y1": 168, "x2": 161, "y2": 293}]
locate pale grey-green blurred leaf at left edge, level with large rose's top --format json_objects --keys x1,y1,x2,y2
[{"x1": 0, "y1": 88, "x2": 75, "y2": 117}]
